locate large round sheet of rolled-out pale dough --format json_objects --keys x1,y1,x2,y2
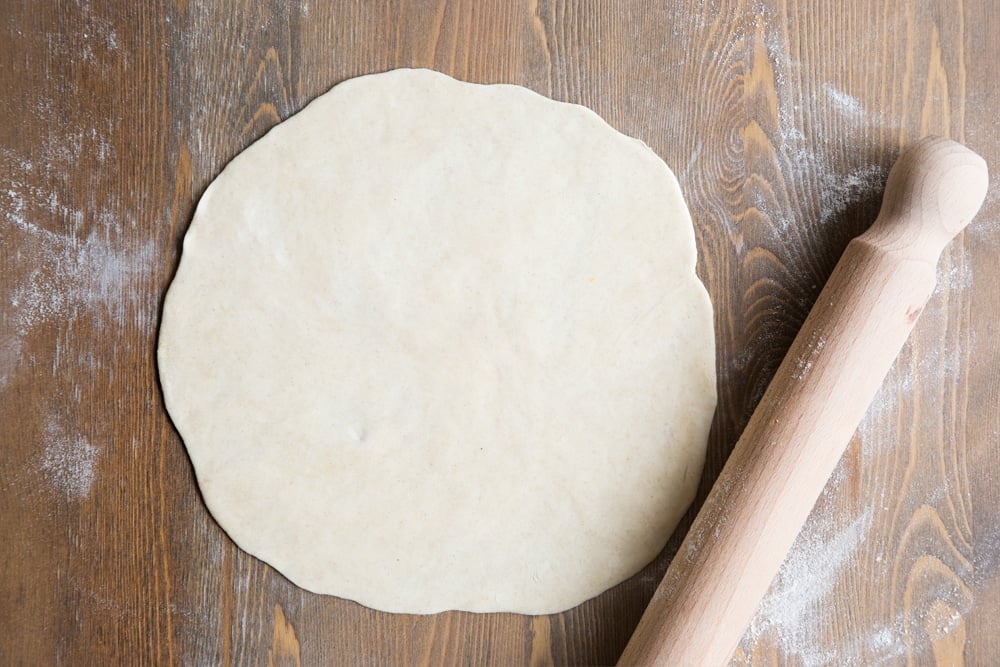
[{"x1": 159, "y1": 70, "x2": 715, "y2": 614}]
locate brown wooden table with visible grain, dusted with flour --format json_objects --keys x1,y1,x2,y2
[{"x1": 0, "y1": 0, "x2": 1000, "y2": 665}]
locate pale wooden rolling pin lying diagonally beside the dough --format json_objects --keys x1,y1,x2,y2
[{"x1": 619, "y1": 138, "x2": 988, "y2": 667}]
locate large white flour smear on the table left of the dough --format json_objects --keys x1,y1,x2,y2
[{"x1": 0, "y1": 143, "x2": 156, "y2": 354}]
